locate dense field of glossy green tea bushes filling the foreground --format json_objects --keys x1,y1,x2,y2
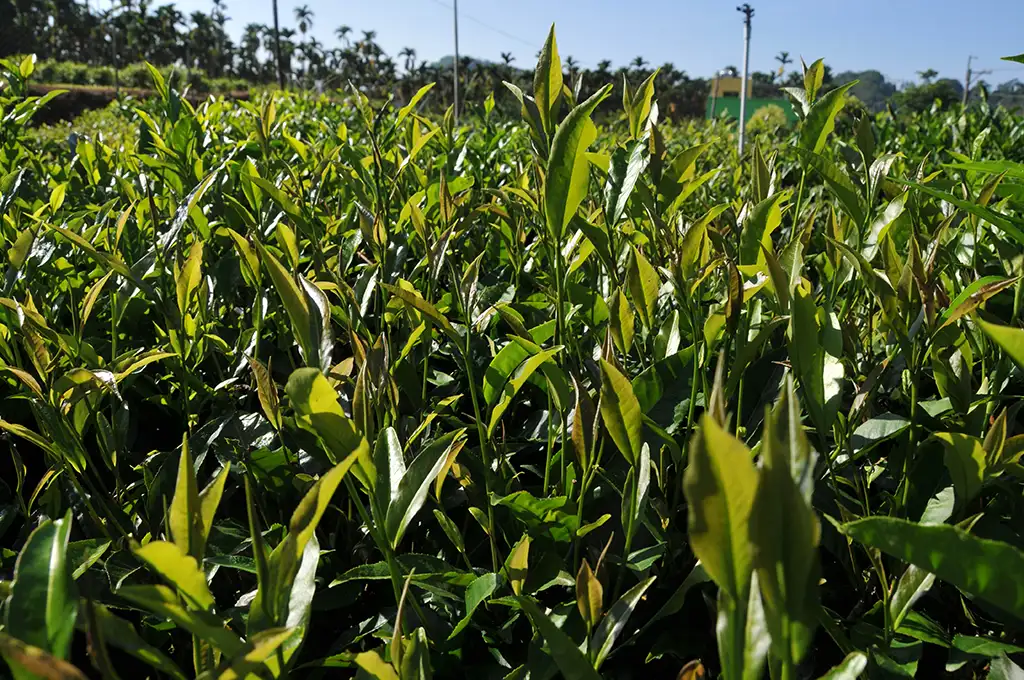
[{"x1": 6, "y1": 39, "x2": 1024, "y2": 680}]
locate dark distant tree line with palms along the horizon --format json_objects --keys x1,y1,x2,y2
[{"x1": 0, "y1": 0, "x2": 1024, "y2": 118}]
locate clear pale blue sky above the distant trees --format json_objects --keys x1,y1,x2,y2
[{"x1": 165, "y1": 0, "x2": 1024, "y2": 83}]
